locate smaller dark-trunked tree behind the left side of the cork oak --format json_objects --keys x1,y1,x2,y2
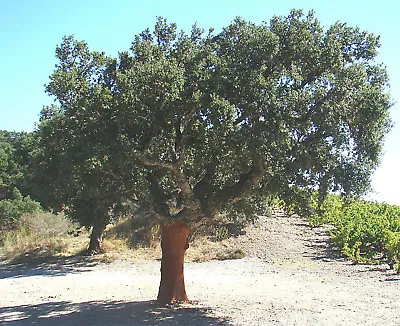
[{"x1": 35, "y1": 100, "x2": 136, "y2": 255}]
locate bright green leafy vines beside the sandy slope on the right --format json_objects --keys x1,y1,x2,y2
[{"x1": 311, "y1": 195, "x2": 400, "y2": 270}]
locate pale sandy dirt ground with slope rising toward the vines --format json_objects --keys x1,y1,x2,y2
[{"x1": 0, "y1": 214, "x2": 400, "y2": 326}]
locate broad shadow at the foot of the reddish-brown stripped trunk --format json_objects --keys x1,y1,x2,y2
[{"x1": 0, "y1": 301, "x2": 230, "y2": 326}]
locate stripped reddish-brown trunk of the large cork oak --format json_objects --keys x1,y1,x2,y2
[{"x1": 157, "y1": 220, "x2": 190, "y2": 303}]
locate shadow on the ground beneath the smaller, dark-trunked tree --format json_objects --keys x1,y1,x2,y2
[{"x1": 0, "y1": 256, "x2": 98, "y2": 279}]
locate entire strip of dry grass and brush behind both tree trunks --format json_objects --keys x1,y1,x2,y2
[{"x1": 0, "y1": 213, "x2": 250, "y2": 263}]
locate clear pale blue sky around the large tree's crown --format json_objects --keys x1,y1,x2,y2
[{"x1": 0, "y1": 0, "x2": 400, "y2": 205}]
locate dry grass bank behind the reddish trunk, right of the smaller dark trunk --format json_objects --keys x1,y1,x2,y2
[{"x1": 99, "y1": 216, "x2": 245, "y2": 262}]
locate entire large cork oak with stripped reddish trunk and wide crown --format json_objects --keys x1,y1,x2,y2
[{"x1": 40, "y1": 10, "x2": 391, "y2": 302}]
